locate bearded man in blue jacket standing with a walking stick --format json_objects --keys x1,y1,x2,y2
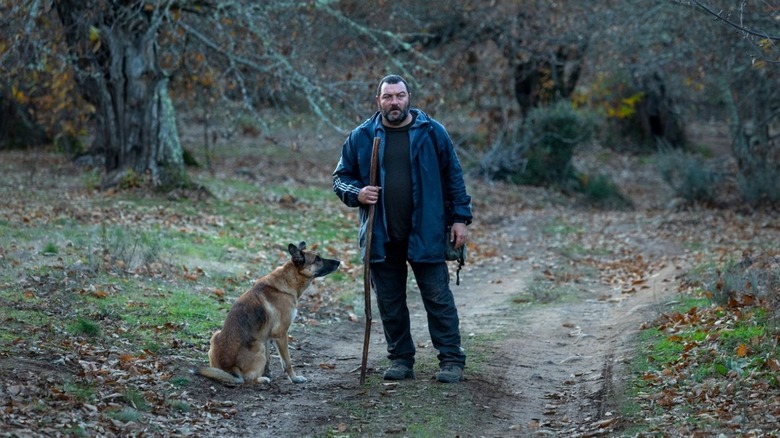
[{"x1": 333, "y1": 75, "x2": 472, "y2": 383}]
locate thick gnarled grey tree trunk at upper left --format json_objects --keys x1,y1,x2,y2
[{"x1": 55, "y1": 0, "x2": 187, "y2": 189}]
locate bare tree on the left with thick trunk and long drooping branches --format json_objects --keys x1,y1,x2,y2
[{"x1": 0, "y1": 0, "x2": 430, "y2": 187}]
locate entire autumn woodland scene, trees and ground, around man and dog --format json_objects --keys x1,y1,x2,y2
[{"x1": 0, "y1": 0, "x2": 780, "y2": 437}]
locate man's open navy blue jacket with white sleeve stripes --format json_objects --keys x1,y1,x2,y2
[{"x1": 333, "y1": 108, "x2": 472, "y2": 263}]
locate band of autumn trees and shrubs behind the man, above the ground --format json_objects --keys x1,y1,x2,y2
[{"x1": 0, "y1": 0, "x2": 780, "y2": 205}]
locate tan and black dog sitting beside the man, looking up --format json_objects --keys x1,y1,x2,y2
[{"x1": 195, "y1": 242, "x2": 341, "y2": 386}]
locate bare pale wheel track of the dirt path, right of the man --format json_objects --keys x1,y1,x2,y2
[{"x1": 463, "y1": 262, "x2": 671, "y2": 436}]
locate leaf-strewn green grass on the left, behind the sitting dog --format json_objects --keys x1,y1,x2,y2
[{"x1": 0, "y1": 168, "x2": 360, "y2": 360}]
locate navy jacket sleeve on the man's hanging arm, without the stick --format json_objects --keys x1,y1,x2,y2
[{"x1": 433, "y1": 122, "x2": 473, "y2": 225}]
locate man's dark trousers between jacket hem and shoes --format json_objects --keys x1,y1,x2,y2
[{"x1": 371, "y1": 243, "x2": 466, "y2": 367}]
